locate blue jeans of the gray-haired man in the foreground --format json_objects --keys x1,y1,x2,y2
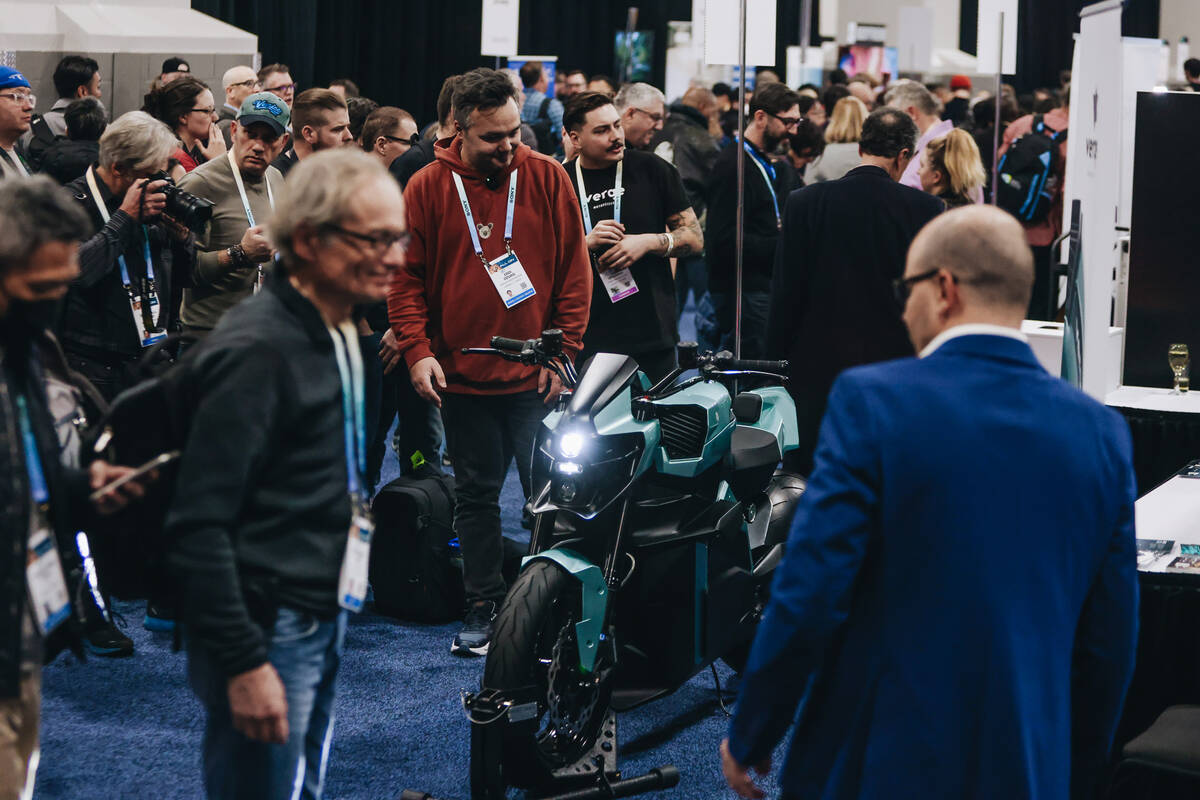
[{"x1": 187, "y1": 608, "x2": 346, "y2": 800}]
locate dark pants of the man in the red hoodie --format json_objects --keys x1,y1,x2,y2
[{"x1": 442, "y1": 392, "x2": 547, "y2": 602}]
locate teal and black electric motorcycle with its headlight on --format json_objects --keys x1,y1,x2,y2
[{"x1": 463, "y1": 331, "x2": 804, "y2": 800}]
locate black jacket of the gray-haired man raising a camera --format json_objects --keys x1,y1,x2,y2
[{"x1": 59, "y1": 175, "x2": 196, "y2": 362}]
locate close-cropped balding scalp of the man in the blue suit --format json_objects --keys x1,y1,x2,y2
[{"x1": 910, "y1": 205, "x2": 1033, "y2": 311}]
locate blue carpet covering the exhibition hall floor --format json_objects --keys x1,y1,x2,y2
[{"x1": 36, "y1": 298, "x2": 792, "y2": 800}]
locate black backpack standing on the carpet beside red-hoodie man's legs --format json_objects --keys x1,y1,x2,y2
[{"x1": 367, "y1": 475, "x2": 466, "y2": 622}]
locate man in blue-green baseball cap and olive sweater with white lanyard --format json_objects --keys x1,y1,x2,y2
[{"x1": 179, "y1": 91, "x2": 292, "y2": 332}]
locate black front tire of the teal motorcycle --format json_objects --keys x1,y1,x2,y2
[{"x1": 484, "y1": 560, "x2": 612, "y2": 788}]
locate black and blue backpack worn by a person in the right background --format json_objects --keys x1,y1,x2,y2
[{"x1": 996, "y1": 114, "x2": 1067, "y2": 223}]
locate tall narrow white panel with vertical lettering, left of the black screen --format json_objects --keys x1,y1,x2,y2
[{"x1": 1064, "y1": 0, "x2": 1123, "y2": 401}]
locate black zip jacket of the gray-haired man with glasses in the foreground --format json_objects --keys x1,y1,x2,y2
[{"x1": 166, "y1": 272, "x2": 350, "y2": 675}]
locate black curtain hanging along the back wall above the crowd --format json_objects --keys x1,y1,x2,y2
[{"x1": 192, "y1": 0, "x2": 1159, "y2": 122}]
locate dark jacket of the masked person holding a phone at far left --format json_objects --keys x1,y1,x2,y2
[{"x1": 0, "y1": 318, "x2": 91, "y2": 698}]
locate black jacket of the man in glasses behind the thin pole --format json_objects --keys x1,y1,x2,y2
[{"x1": 704, "y1": 142, "x2": 787, "y2": 293}]
